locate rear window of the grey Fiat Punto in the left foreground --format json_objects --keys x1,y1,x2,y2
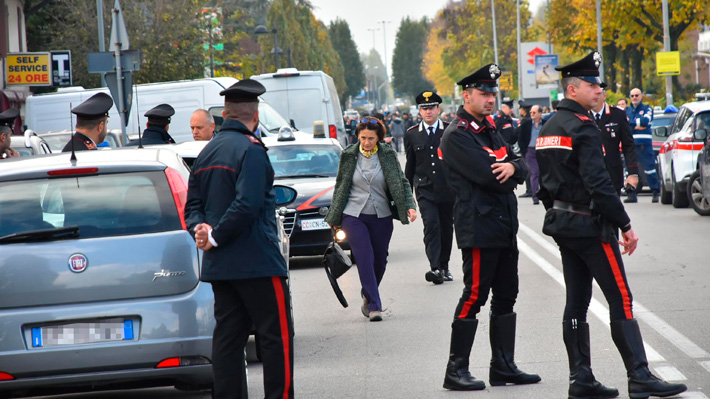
[{"x1": 0, "y1": 171, "x2": 181, "y2": 238}]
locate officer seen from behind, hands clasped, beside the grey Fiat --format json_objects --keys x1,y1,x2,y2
[{"x1": 185, "y1": 79, "x2": 294, "y2": 399}]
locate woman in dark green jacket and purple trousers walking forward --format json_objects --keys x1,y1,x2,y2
[{"x1": 325, "y1": 118, "x2": 417, "y2": 321}]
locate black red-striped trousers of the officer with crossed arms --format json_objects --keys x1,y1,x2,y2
[{"x1": 454, "y1": 248, "x2": 518, "y2": 319}]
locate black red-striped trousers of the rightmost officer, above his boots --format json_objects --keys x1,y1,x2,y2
[{"x1": 554, "y1": 237, "x2": 634, "y2": 321}]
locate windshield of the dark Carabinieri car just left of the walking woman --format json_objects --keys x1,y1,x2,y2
[{"x1": 267, "y1": 144, "x2": 340, "y2": 179}]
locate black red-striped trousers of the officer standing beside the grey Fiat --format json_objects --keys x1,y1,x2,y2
[{"x1": 212, "y1": 277, "x2": 293, "y2": 399}]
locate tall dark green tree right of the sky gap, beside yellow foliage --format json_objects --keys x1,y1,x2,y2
[{"x1": 392, "y1": 17, "x2": 433, "y2": 97}]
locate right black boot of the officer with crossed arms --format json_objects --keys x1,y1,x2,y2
[{"x1": 488, "y1": 312, "x2": 540, "y2": 386}]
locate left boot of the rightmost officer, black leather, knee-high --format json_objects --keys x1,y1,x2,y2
[{"x1": 562, "y1": 319, "x2": 619, "y2": 399}]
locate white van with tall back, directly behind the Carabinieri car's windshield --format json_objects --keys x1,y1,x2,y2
[{"x1": 251, "y1": 68, "x2": 347, "y2": 147}]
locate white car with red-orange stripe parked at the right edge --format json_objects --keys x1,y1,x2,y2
[{"x1": 656, "y1": 101, "x2": 710, "y2": 208}]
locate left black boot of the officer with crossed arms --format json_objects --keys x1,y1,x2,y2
[{"x1": 444, "y1": 319, "x2": 486, "y2": 391}]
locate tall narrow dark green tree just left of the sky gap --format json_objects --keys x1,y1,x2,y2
[{"x1": 328, "y1": 18, "x2": 365, "y2": 108}]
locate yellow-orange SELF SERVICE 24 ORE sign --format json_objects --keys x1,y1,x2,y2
[{"x1": 5, "y1": 53, "x2": 52, "y2": 86}]
